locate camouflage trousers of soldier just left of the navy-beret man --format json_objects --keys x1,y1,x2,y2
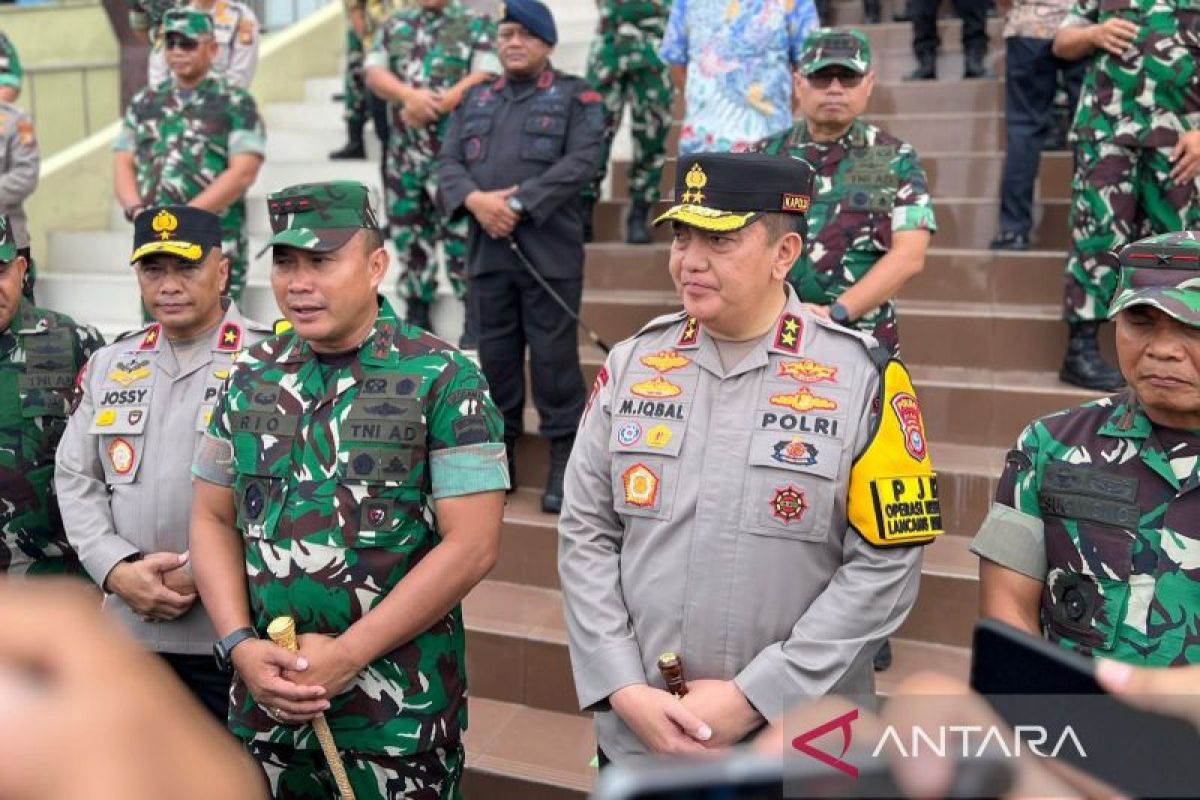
[{"x1": 384, "y1": 134, "x2": 468, "y2": 302}]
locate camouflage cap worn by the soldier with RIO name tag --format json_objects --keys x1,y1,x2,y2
[{"x1": 259, "y1": 181, "x2": 379, "y2": 255}]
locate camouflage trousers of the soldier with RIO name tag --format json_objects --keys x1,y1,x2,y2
[{"x1": 246, "y1": 741, "x2": 463, "y2": 800}]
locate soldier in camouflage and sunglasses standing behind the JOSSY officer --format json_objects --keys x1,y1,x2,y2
[{"x1": 113, "y1": 10, "x2": 266, "y2": 300}]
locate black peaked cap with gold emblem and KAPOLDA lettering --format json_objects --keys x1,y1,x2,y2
[{"x1": 654, "y1": 152, "x2": 812, "y2": 233}]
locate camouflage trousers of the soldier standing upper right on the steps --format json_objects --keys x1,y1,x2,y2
[{"x1": 1063, "y1": 140, "x2": 1200, "y2": 323}]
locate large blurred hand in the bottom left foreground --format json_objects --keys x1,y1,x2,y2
[{"x1": 0, "y1": 578, "x2": 266, "y2": 800}]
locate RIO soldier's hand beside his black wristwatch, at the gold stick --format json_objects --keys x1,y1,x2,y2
[{"x1": 230, "y1": 639, "x2": 329, "y2": 724}]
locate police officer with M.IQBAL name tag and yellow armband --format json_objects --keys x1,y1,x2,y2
[{"x1": 559, "y1": 154, "x2": 941, "y2": 762}]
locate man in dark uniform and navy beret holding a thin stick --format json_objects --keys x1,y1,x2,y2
[{"x1": 438, "y1": 0, "x2": 605, "y2": 513}]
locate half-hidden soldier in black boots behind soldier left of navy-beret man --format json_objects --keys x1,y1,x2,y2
[{"x1": 329, "y1": 0, "x2": 403, "y2": 161}]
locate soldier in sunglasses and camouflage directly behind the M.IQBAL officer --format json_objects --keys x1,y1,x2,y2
[{"x1": 760, "y1": 28, "x2": 937, "y2": 355}]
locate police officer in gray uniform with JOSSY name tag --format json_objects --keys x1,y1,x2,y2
[{"x1": 54, "y1": 206, "x2": 270, "y2": 724}]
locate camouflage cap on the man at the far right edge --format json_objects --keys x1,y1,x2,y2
[{"x1": 1109, "y1": 230, "x2": 1200, "y2": 327}]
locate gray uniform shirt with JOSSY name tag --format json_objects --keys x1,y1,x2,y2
[{"x1": 54, "y1": 301, "x2": 270, "y2": 654}]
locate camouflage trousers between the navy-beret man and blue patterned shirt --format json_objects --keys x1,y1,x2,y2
[{"x1": 583, "y1": 46, "x2": 672, "y2": 205}]
